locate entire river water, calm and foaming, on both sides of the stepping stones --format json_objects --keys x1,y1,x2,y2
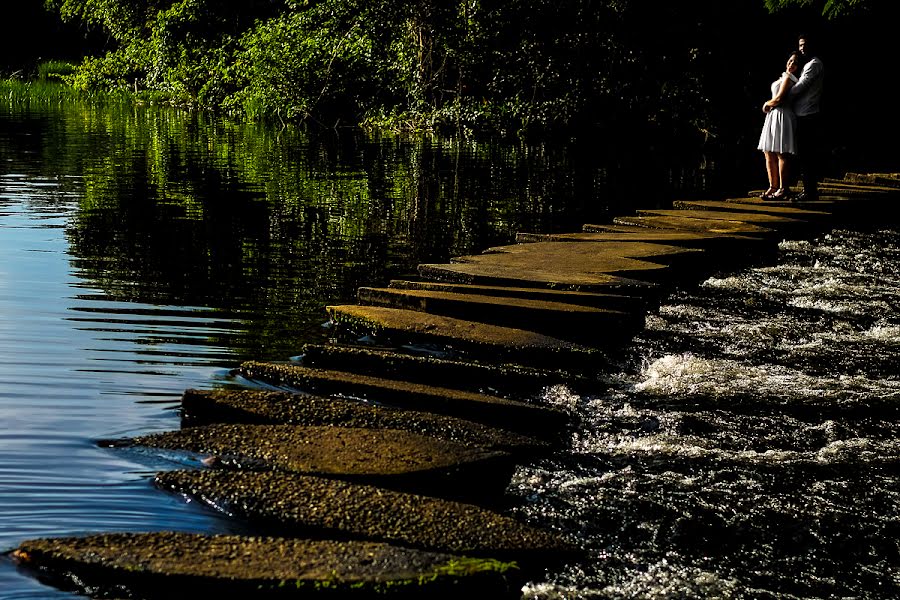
[{"x1": 0, "y1": 96, "x2": 900, "y2": 600}]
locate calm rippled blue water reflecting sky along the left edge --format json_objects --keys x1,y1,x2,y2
[{"x1": 0, "y1": 172, "x2": 246, "y2": 599}]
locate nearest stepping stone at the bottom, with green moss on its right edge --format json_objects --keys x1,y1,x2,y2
[{"x1": 11, "y1": 532, "x2": 524, "y2": 600}]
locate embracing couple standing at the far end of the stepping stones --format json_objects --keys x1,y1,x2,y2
[{"x1": 757, "y1": 35, "x2": 825, "y2": 201}]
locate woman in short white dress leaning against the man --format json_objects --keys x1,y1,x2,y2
[{"x1": 757, "y1": 52, "x2": 803, "y2": 200}]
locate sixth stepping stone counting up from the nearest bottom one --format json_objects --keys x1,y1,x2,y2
[{"x1": 299, "y1": 344, "x2": 598, "y2": 399}]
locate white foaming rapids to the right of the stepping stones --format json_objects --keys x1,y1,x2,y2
[{"x1": 513, "y1": 229, "x2": 900, "y2": 598}]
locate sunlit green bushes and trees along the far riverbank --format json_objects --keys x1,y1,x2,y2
[{"x1": 35, "y1": 0, "x2": 800, "y2": 135}]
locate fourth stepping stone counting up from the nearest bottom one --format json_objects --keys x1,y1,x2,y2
[{"x1": 181, "y1": 389, "x2": 549, "y2": 455}]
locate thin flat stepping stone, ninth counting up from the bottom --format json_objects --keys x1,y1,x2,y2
[{"x1": 388, "y1": 279, "x2": 643, "y2": 310}]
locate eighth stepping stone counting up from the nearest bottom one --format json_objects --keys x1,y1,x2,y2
[{"x1": 357, "y1": 287, "x2": 644, "y2": 345}]
